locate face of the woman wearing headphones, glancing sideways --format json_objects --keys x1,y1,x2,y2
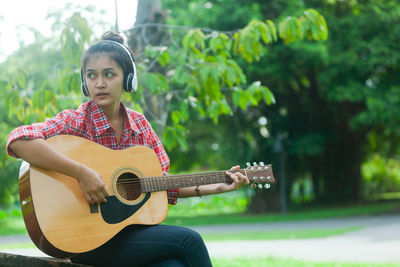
[{"x1": 85, "y1": 53, "x2": 124, "y2": 108}]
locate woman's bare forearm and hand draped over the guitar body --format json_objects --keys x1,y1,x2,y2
[{"x1": 9, "y1": 138, "x2": 108, "y2": 204}]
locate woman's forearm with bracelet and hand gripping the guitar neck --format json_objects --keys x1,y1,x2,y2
[{"x1": 177, "y1": 166, "x2": 250, "y2": 198}]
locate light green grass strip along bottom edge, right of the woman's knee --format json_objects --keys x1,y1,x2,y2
[{"x1": 211, "y1": 257, "x2": 400, "y2": 267}]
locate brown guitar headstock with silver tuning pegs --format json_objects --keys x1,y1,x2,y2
[{"x1": 246, "y1": 162, "x2": 275, "y2": 189}]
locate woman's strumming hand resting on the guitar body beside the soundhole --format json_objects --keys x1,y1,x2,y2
[{"x1": 77, "y1": 165, "x2": 108, "y2": 204}]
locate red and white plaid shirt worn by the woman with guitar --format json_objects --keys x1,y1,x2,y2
[{"x1": 6, "y1": 101, "x2": 178, "y2": 204}]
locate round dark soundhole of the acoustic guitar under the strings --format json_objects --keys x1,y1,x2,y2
[{"x1": 117, "y1": 172, "x2": 142, "y2": 200}]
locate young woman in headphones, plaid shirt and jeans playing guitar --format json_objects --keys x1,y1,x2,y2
[{"x1": 7, "y1": 32, "x2": 249, "y2": 266}]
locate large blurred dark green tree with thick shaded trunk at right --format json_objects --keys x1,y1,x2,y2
[{"x1": 265, "y1": 1, "x2": 400, "y2": 204}]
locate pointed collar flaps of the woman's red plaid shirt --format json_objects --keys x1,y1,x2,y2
[{"x1": 86, "y1": 100, "x2": 140, "y2": 136}]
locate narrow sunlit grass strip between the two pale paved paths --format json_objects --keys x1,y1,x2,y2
[{"x1": 201, "y1": 227, "x2": 363, "y2": 242}]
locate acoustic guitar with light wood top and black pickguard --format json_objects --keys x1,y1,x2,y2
[{"x1": 19, "y1": 135, "x2": 274, "y2": 258}]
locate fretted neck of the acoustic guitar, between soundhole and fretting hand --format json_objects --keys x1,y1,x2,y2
[{"x1": 140, "y1": 170, "x2": 246, "y2": 192}]
